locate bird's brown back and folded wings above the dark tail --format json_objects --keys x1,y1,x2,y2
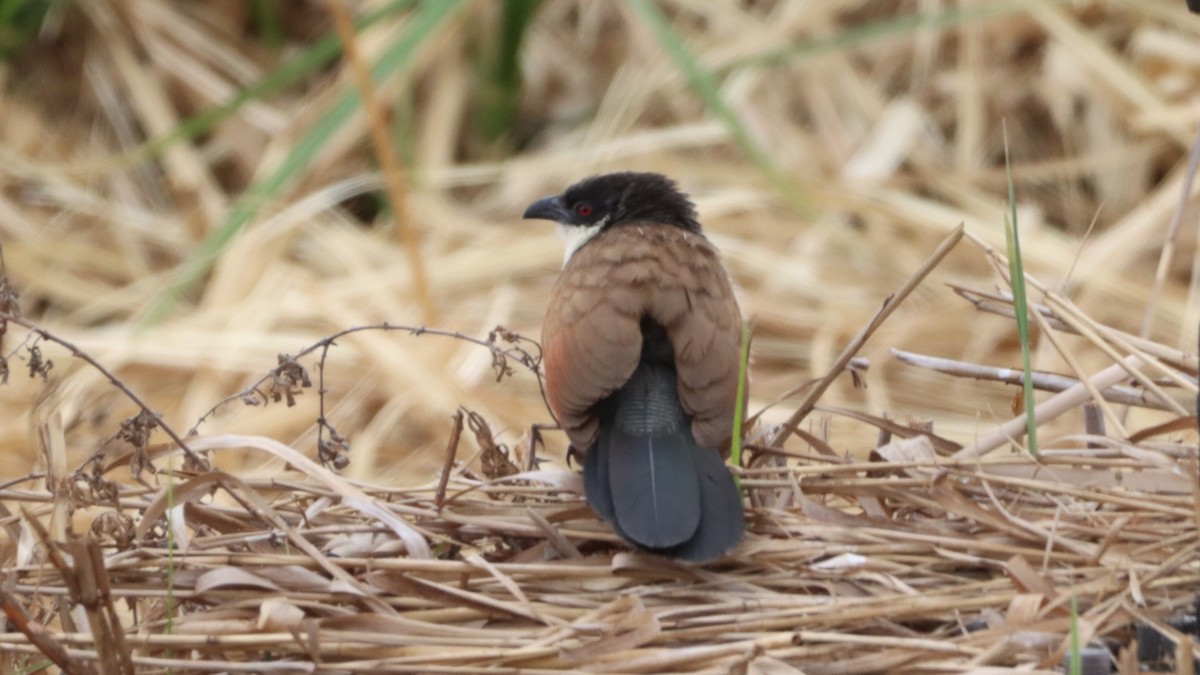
[{"x1": 542, "y1": 222, "x2": 742, "y2": 449}]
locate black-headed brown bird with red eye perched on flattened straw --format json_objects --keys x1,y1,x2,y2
[{"x1": 523, "y1": 172, "x2": 745, "y2": 563}]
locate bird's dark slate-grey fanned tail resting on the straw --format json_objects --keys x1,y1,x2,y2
[{"x1": 583, "y1": 359, "x2": 745, "y2": 562}]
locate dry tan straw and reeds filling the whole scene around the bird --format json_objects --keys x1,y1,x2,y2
[{"x1": 0, "y1": 0, "x2": 1200, "y2": 675}]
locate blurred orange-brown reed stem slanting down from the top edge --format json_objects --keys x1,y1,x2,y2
[{"x1": 325, "y1": 0, "x2": 438, "y2": 323}]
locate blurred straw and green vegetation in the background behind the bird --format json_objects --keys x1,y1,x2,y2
[{"x1": 0, "y1": 0, "x2": 1200, "y2": 482}]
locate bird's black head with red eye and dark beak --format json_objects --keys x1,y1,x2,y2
[{"x1": 524, "y1": 171, "x2": 700, "y2": 234}]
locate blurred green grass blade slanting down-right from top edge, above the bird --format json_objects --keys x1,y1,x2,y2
[{"x1": 629, "y1": 0, "x2": 810, "y2": 213}]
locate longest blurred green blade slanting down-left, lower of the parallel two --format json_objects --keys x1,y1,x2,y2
[{"x1": 143, "y1": 0, "x2": 461, "y2": 323}]
